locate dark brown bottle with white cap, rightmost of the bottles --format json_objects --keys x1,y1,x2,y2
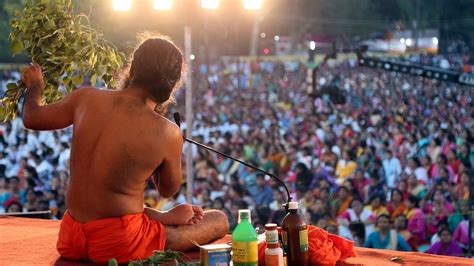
[{"x1": 281, "y1": 201, "x2": 308, "y2": 266}]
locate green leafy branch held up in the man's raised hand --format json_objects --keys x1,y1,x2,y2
[{"x1": 0, "y1": 0, "x2": 125, "y2": 122}]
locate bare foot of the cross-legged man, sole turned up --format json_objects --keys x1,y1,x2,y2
[{"x1": 145, "y1": 204, "x2": 204, "y2": 225}]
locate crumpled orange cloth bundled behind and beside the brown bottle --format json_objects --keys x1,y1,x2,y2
[{"x1": 258, "y1": 225, "x2": 356, "y2": 265}]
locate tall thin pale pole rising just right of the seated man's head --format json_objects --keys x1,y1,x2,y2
[{"x1": 184, "y1": 25, "x2": 193, "y2": 204}]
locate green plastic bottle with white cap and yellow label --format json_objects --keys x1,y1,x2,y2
[{"x1": 232, "y1": 210, "x2": 258, "y2": 266}]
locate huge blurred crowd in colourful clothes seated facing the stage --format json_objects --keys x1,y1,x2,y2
[{"x1": 0, "y1": 54, "x2": 474, "y2": 256}]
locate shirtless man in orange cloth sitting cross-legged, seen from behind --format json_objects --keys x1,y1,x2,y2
[{"x1": 22, "y1": 37, "x2": 229, "y2": 263}]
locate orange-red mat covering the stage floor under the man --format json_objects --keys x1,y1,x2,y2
[{"x1": 0, "y1": 217, "x2": 474, "y2": 266}]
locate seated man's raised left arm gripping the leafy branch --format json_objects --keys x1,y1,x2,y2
[{"x1": 22, "y1": 64, "x2": 83, "y2": 130}]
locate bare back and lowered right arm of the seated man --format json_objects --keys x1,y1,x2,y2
[{"x1": 66, "y1": 88, "x2": 182, "y2": 222}]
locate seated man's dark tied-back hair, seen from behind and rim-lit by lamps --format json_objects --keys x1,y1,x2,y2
[{"x1": 119, "y1": 33, "x2": 185, "y2": 115}]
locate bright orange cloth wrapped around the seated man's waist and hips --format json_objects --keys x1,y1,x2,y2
[{"x1": 56, "y1": 212, "x2": 166, "y2": 263}]
